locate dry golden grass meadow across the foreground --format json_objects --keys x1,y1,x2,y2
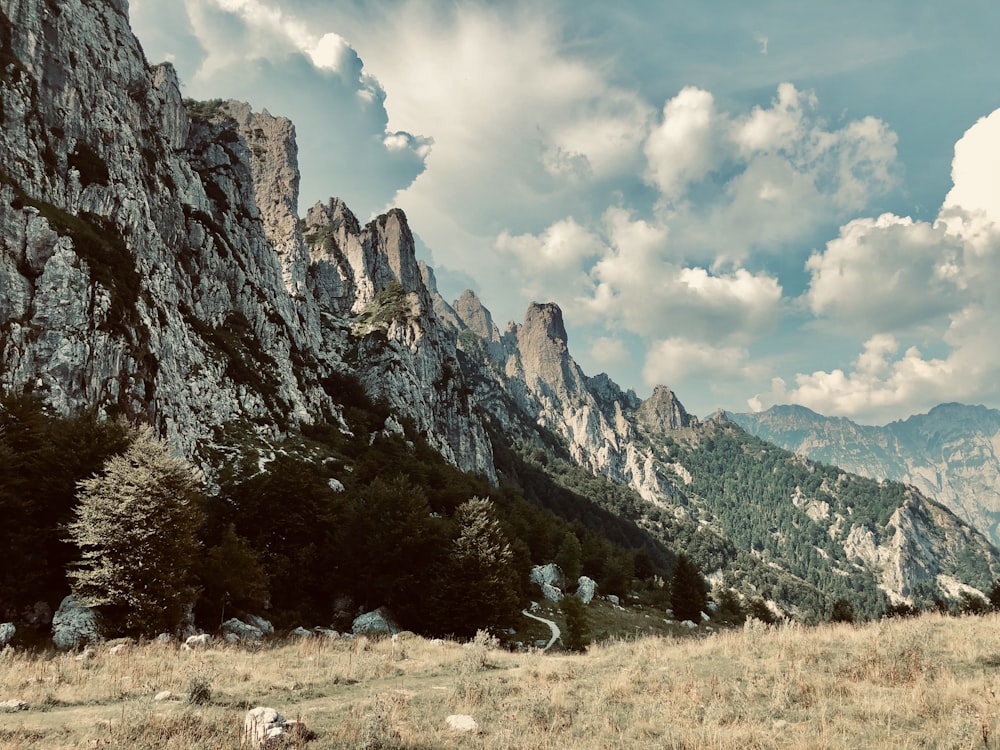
[{"x1": 0, "y1": 615, "x2": 1000, "y2": 750}]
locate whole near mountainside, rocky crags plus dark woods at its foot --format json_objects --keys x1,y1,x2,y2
[{"x1": 0, "y1": 0, "x2": 1000, "y2": 635}]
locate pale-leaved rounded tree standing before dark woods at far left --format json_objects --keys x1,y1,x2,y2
[{"x1": 69, "y1": 426, "x2": 201, "y2": 635}]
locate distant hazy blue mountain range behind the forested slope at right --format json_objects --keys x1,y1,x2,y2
[{"x1": 729, "y1": 404, "x2": 1000, "y2": 544}]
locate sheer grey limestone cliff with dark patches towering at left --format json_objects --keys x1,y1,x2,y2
[{"x1": 0, "y1": 0, "x2": 493, "y2": 478}]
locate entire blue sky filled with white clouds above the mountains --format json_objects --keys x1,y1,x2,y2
[{"x1": 131, "y1": 0, "x2": 1000, "y2": 424}]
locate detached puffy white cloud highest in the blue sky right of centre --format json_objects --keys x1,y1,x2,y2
[{"x1": 646, "y1": 83, "x2": 896, "y2": 264}]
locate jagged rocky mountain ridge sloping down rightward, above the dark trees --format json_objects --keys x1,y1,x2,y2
[{"x1": 0, "y1": 0, "x2": 1000, "y2": 617}]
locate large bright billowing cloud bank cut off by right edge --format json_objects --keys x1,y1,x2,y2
[{"x1": 751, "y1": 110, "x2": 1000, "y2": 422}]
